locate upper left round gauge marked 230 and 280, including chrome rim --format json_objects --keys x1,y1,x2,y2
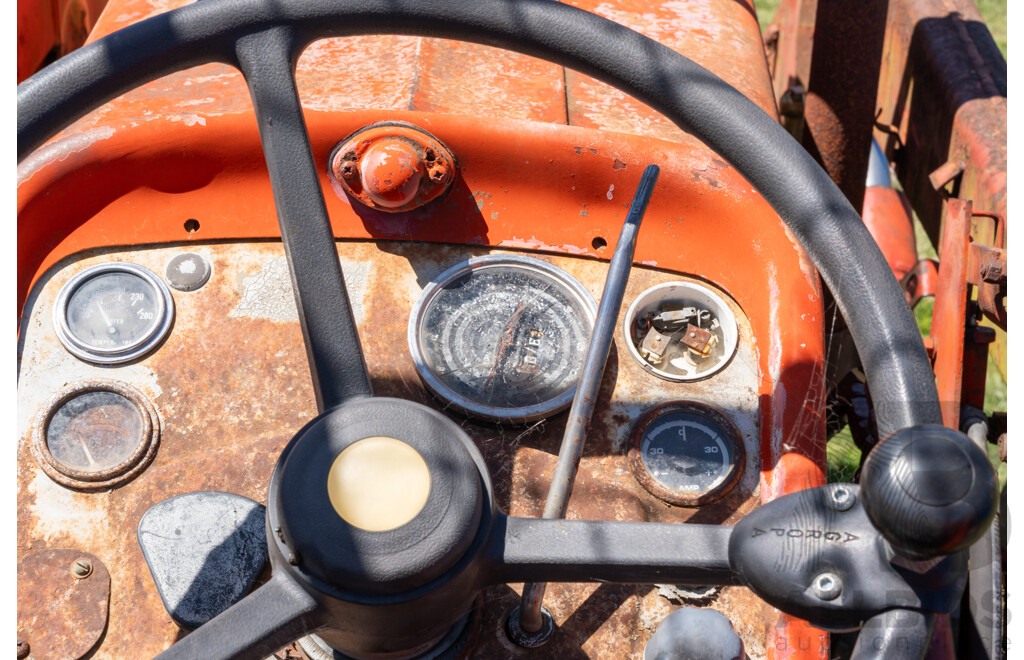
[{"x1": 53, "y1": 262, "x2": 174, "y2": 364}]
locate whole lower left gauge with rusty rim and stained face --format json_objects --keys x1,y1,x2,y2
[{"x1": 32, "y1": 381, "x2": 160, "y2": 490}]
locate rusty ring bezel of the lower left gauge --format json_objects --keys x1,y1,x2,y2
[{"x1": 32, "y1": 379, "x2": 160, "y2": 490}]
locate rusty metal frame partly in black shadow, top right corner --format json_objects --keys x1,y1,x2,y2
[{"x1": 876, "y1": 0, "x2": 1007, "y2": 244}]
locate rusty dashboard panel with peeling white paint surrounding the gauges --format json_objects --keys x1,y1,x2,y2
[{"x1": 17, "y1": 241, "x2": 775, "y2": 659}]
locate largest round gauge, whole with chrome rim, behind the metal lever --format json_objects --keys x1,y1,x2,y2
[{"x1": 409, "y1": 255, "x2": 597, "y2": 422}]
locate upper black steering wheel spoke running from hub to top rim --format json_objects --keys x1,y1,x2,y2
[{"x1": 236, "y1": 28, "x2": 372, "y2": 412}]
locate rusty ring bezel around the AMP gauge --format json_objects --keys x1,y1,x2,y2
[{"x1": 629, "y1": 401, "x2": 746, "y2": 507}]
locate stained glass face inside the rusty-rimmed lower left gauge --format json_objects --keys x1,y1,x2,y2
[{"x1": 46, "y1": 392, "x2": 144, "y2": 473}]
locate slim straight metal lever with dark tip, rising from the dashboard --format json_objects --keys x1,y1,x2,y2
[{"x1": 519, "y1": 165, "x2": 660, "y2": 646}]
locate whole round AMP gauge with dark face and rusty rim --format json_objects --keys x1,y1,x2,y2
[{"x1": 630, "y1": 401, "x2": 745, "y2": 507}]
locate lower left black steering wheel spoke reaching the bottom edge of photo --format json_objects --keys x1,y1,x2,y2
[{"x1": 157, "y1": 571, "x2": 323, "y2": 660}]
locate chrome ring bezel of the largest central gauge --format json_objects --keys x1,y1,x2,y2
[{"x1": 407, "y1": 255, "x2": 597, "y2": 424}]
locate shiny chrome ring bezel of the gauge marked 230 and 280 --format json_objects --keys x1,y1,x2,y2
[{"x1": 53, "y1": 261, "x2": 174, "y2": 364}]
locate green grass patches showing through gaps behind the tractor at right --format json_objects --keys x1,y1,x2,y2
[{"x1": 754, "y1": 0, "x2": 1007, "y2": 478}]
